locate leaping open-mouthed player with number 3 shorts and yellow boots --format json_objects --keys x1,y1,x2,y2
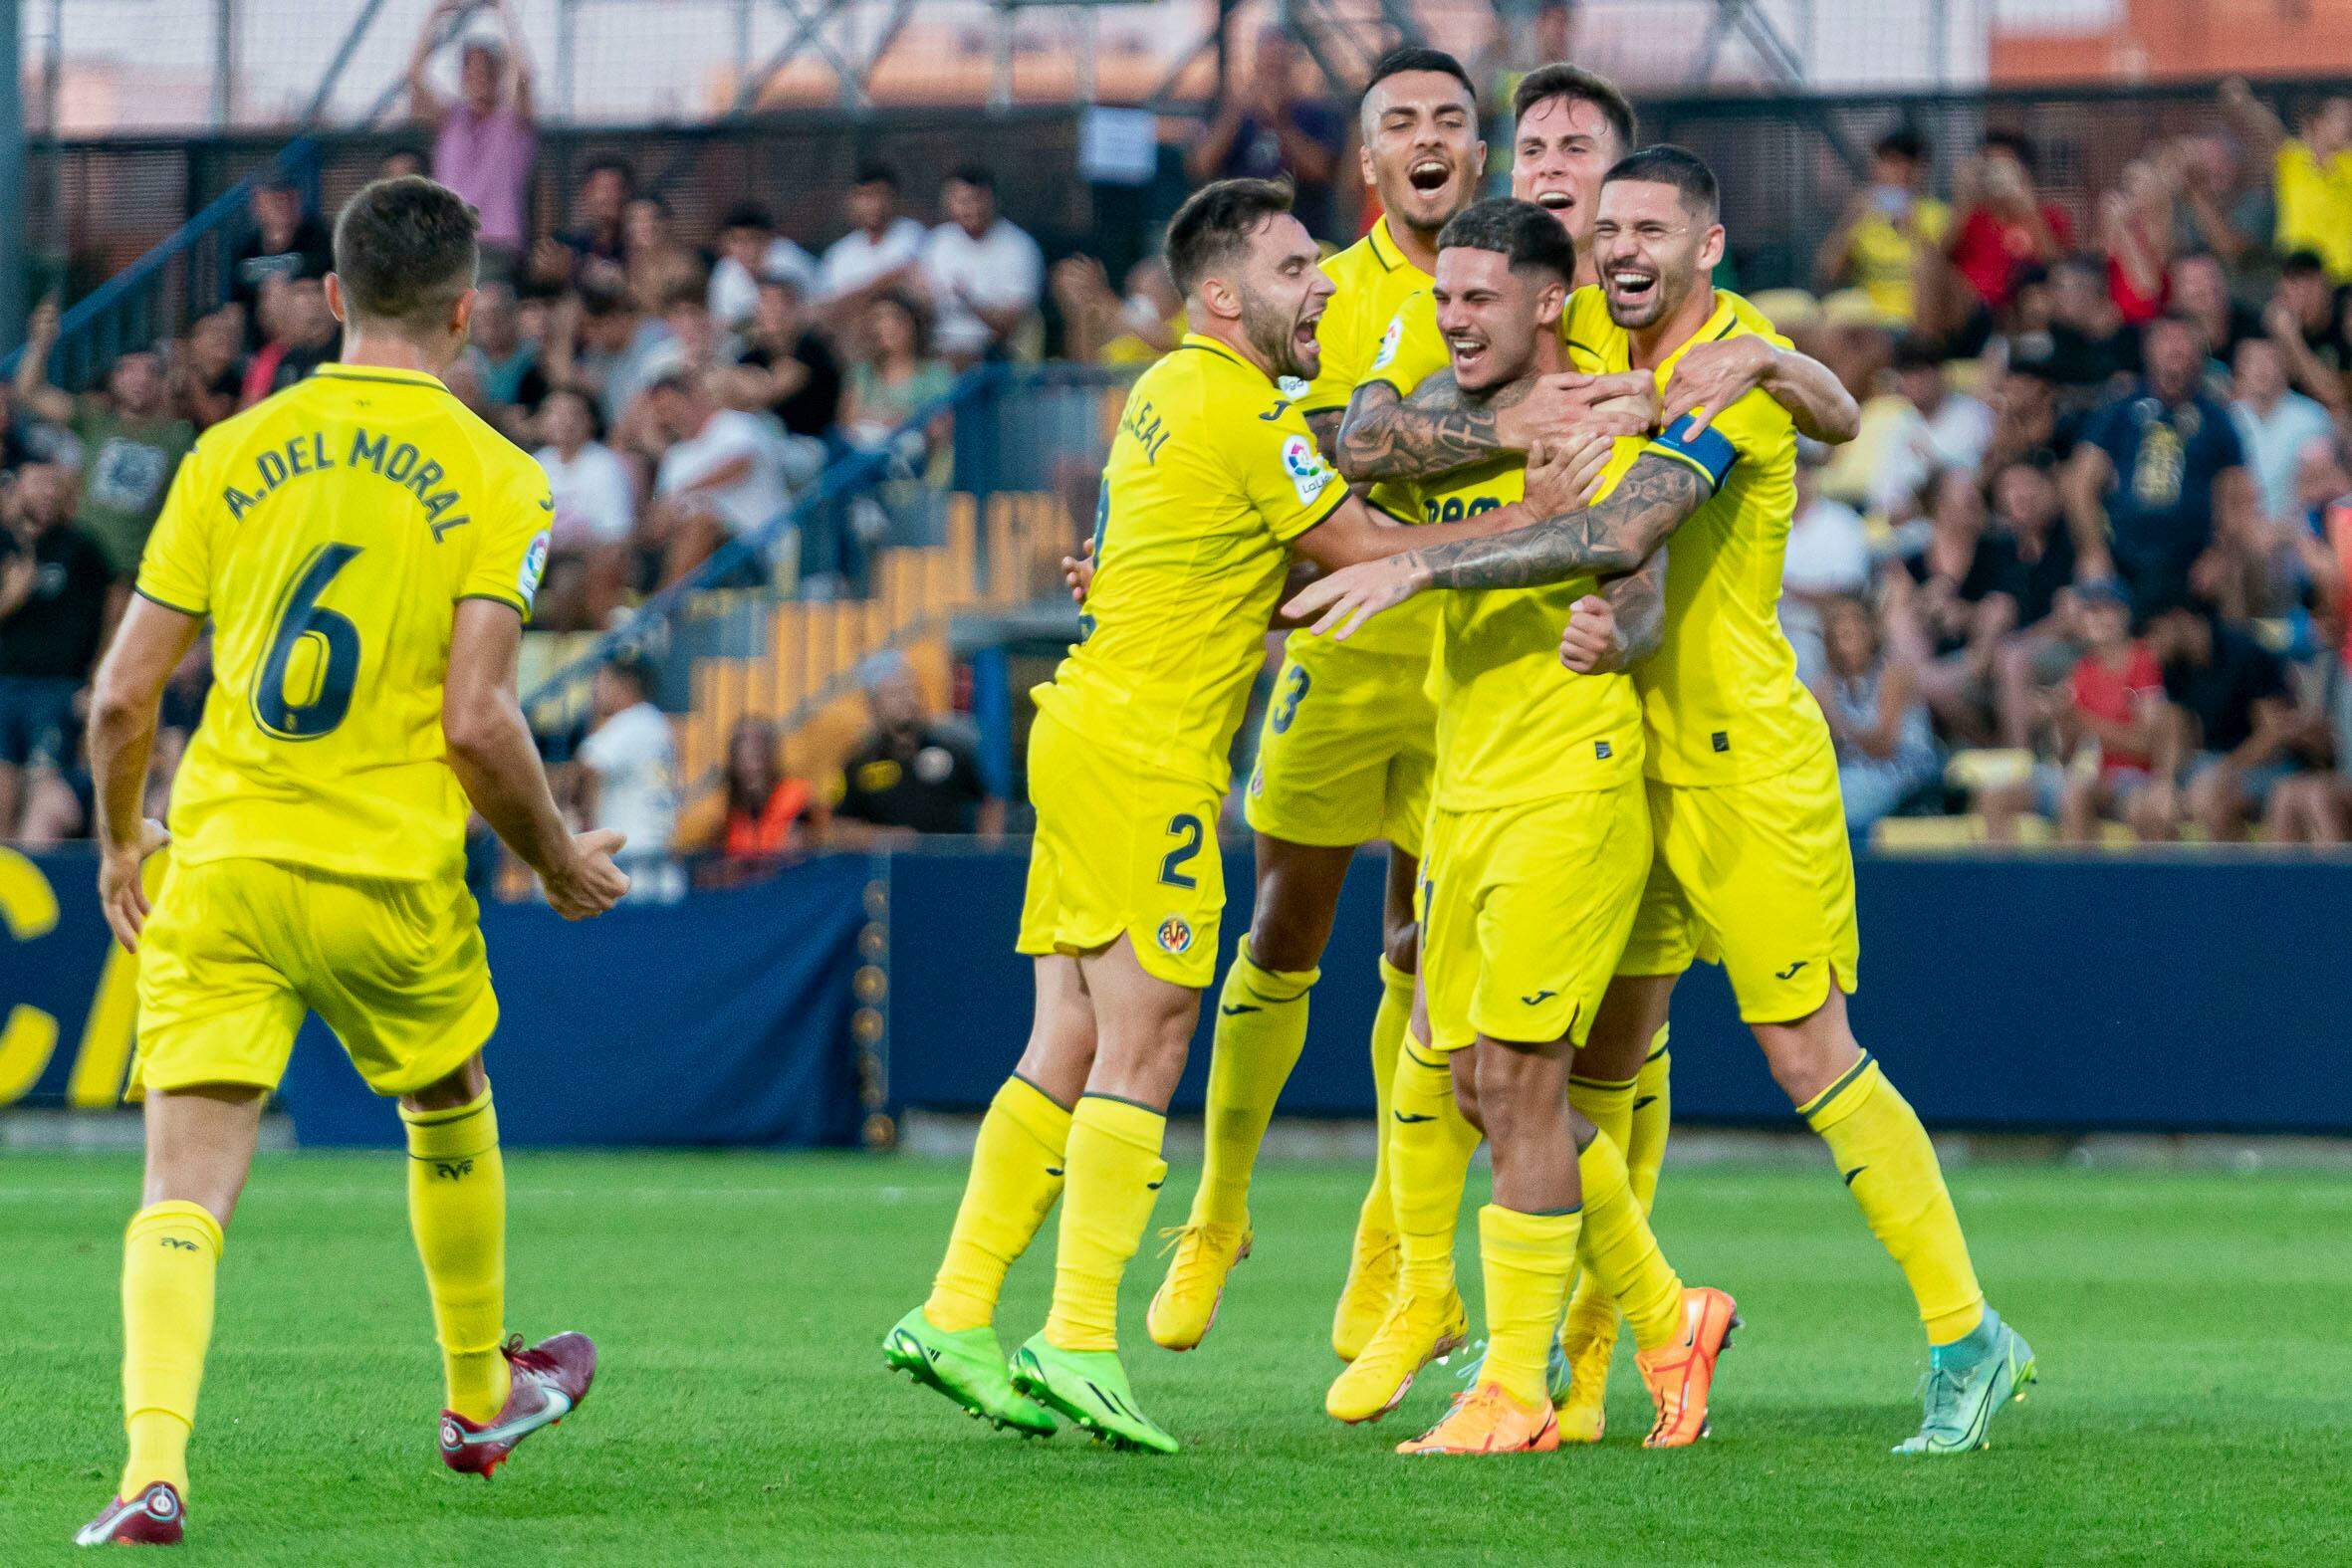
[{"x1": 1150, "y1": 47, "x2": 1484, "y2": 1359}]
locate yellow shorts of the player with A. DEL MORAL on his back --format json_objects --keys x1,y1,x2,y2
[{"x1": 131, "y1": 860, "x2": 499, "y2": 1095}]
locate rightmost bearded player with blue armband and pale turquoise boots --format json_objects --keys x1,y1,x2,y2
[{"x1": 1289, "y1": 148, "x2": 2034, "y2": 1456}]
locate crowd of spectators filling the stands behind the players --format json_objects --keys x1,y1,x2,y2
[{"x1": 0, "y1": 7, "x2": 2352, "y2": 851}]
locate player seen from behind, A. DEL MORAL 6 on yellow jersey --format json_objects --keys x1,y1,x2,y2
[{"x1": 78, "y1": 176, "x2": 628, "y2": 1544}]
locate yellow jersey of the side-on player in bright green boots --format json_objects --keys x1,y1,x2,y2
[{"x1": 1033, "y1": 334, "x2": 1347, "y2": 789}]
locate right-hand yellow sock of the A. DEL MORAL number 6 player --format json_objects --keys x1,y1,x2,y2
[{"x1": 400, "y1": 1088, "x2": 508, "y2": 1423}]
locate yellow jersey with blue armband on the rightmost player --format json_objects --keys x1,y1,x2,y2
[{"x1": 1578, "y1": 292, "x2": 1830, "y2": 785}]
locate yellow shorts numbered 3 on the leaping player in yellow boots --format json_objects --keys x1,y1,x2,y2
[{"x1": 1242, "y1": 639, "x2": 1437, "y2": 856}]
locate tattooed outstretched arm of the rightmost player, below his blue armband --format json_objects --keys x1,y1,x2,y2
[{"x1": 1282, "y1": 451, "x2": 1715, "y2": 637}]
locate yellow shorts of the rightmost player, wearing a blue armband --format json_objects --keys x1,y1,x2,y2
[{"x1": 1618, "y1": 746, "x2": 1863, "y2": 1022}]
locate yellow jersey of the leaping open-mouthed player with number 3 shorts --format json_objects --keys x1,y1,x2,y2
[{"x1": 1287, "y1": 219, "x2": 1444, "y2": 658}]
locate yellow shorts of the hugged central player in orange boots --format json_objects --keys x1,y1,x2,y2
[{"x1": 1421, "y1": 783, "x2": 1649, "y2": 1051}]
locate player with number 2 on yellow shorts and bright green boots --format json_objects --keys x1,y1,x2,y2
[{"x1": 882, "y1": 178, "x2": 1533, "y2": 1453}]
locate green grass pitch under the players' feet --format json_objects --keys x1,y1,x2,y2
[{"x1": 0, "y1": 1157, "x2": 2352, "y2": 1568}]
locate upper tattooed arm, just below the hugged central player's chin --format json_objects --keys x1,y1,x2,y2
[{"x1": 1329, "y1": 369, "x2": 1658, "y2": 484}]
